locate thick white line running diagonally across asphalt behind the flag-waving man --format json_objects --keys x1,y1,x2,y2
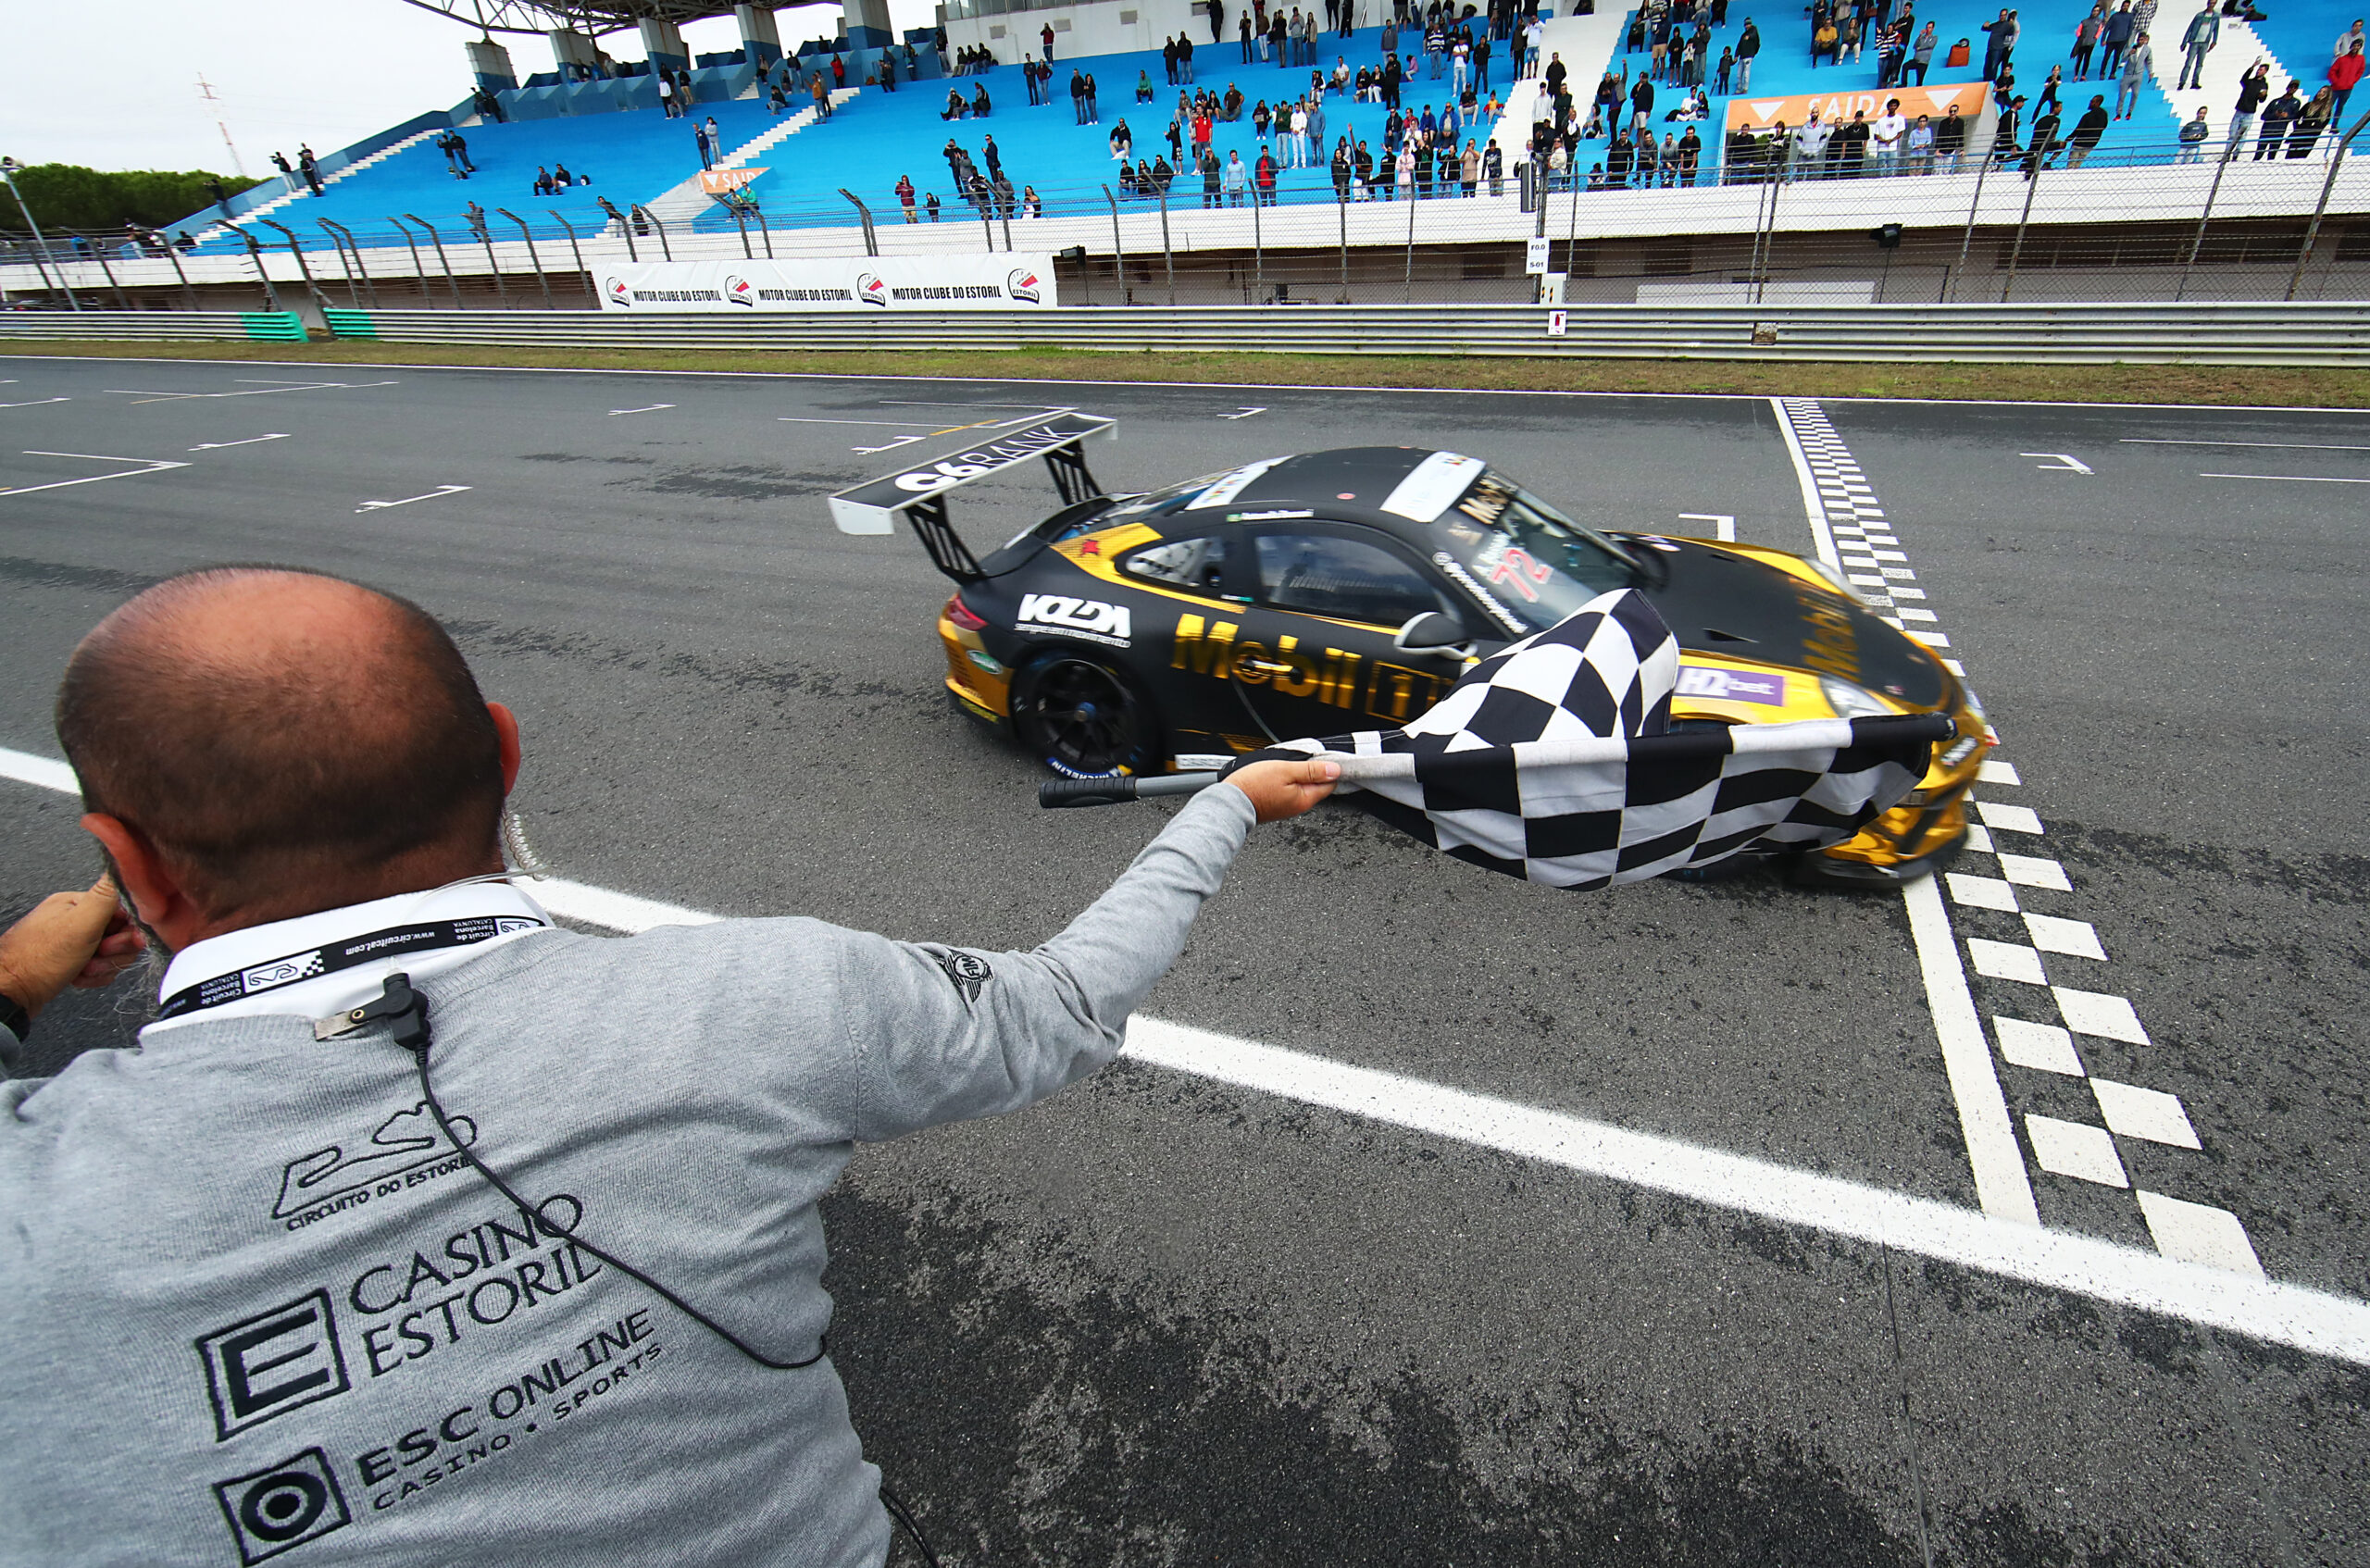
[{"x1": 0, "y1": 749, "x2": 2370, "y2": 1366}]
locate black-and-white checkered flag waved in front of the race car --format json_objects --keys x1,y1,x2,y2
[{"x1": 1235, "y1": 590, "x2": 1952, "y2": 889}]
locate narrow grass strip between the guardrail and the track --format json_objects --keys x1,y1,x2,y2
[{"x1": 0, "y1": 339, "x2": 2370, "y2": 407}]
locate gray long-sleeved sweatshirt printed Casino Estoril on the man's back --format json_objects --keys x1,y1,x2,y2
[{"x1": 0, "y1": 787, "x2": 1252, "y2": 1568}]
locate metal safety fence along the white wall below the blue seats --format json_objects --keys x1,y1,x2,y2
[{"x1": 14, "y1": 140, "x2": 2370, "y2": 317}]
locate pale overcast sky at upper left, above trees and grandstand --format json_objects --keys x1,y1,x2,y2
[{"x1": 0, "y1": 0, "x2": 931, "y2": 175}]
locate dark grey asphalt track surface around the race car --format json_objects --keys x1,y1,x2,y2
[{"x1": 0, "y1": 357, "x2": 2370, "y2": 1565}]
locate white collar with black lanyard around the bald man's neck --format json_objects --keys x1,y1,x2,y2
[{"x1": 140, "y1": 881, "x2": 552, "y2": 1035}]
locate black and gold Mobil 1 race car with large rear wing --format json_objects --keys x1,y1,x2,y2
[{"x1": 832, "y1": 412, "x2": 1998, "y2": 886}]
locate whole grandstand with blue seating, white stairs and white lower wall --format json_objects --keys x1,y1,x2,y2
[{"x1": 0, "y1": 0, "x2": 2370, "y2": 310}]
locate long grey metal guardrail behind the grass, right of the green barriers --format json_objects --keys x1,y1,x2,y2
[{"x1": 327, "y1": 301, "x2": 2370, "y2": 367}]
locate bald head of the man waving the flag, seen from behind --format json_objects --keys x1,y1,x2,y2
[{"x1": 56, "y1": 566, "x2": 505, "y2": 928}]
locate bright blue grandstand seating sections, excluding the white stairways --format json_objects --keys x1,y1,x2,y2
[{"x1": 190, "y1": 0, "x2": 2365, "y2": 251}]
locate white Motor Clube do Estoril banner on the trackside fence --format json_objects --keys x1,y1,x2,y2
[{"x1": 600, "y1": 254, "x2": 1059, "y2": 315}]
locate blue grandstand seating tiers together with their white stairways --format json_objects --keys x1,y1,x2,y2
[{"x1": 148, "y1": 0, "x2": 2351, "y2": 251}]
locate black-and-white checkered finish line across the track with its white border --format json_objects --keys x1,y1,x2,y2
[{"x1": 1770, "y1": 398, "x2": 2264, "y2": 1279}]
